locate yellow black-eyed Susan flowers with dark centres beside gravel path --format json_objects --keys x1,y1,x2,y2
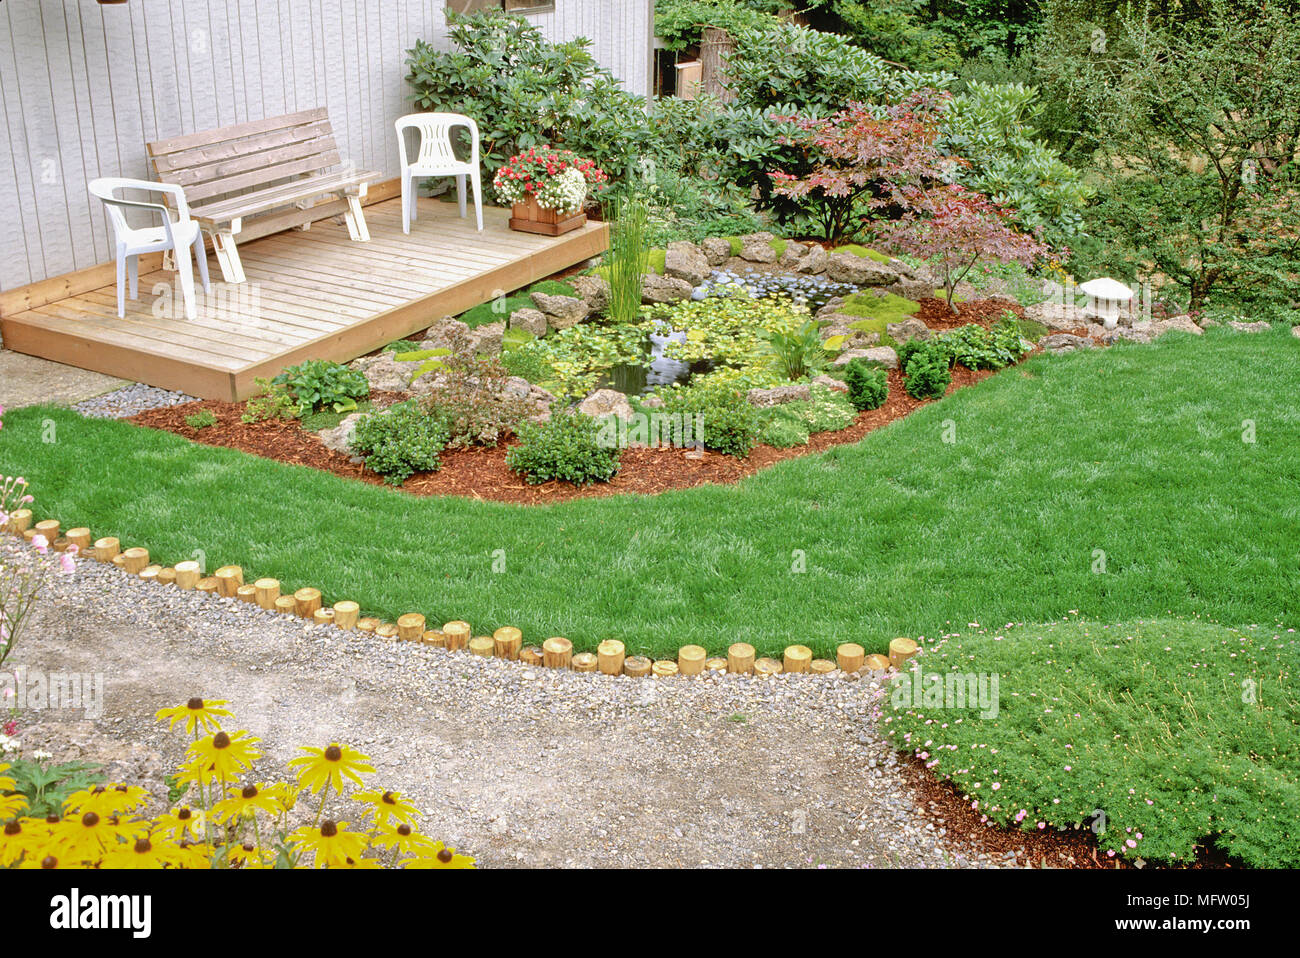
[{"x1": 0, "y1": 698, "x2": 475, "y2": 870}]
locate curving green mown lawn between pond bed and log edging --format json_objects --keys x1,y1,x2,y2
[{"x1": 0, "y1": 330, "x2": 1300, "y2": 655}]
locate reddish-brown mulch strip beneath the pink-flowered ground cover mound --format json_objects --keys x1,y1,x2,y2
[{"x1": 898, "y1": 753, "x2": 1243, "y2": 870}]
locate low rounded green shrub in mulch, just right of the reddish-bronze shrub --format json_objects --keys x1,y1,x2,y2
[{"x1": 506, "y1": 412, "x2": 621, "y2": 486}]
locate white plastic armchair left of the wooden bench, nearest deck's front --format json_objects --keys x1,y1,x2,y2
[{"x1": 90, "y1": 177, "x2": 212, "y2": 320}]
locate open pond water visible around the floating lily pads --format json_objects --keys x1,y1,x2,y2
[{"x1": 601, "y1": 269, "x2": 859, "y2": 396}]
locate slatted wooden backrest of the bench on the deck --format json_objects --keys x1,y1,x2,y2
[{"x1": 146, "y1": 107, "x2": 342, "y2": 207}]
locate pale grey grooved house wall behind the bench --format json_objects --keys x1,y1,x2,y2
[{"x1": 0, "y1": 0, "x2": 653, "y2": 290}]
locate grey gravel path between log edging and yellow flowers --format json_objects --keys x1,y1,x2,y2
[{"x1": 0, "y1": 539, "x2": 1001, "y2": 867}]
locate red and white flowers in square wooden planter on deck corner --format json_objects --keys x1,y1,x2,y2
[{"x1": 493, "y1": 147, "x2": 608, "y2": 237}]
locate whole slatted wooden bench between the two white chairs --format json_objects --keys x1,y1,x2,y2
[{"x1": 146, "y1": 107, "x2": 382, "y2": 283}]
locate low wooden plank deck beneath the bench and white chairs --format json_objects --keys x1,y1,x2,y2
[{"x1": 0, "y1": 199, "x2": 607, "y2": 399}]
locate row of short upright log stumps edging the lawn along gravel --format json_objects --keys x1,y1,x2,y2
[{"x1": 0, "y1": 510, "x2": 923, "y2": 679}]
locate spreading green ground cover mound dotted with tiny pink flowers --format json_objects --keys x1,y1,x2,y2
[{"x1": 884, "y1": 619, "x2": 1300, "y2": 868}]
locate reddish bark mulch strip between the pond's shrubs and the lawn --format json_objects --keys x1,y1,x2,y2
[{"x1": 127, "y1": 367, "x2": 992, "y2": 506}]
